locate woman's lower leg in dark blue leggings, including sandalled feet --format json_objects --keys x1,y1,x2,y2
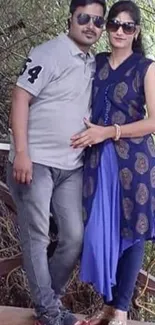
[{"x1": 90, "y1": 240, "x2": 145, "y2": 325}]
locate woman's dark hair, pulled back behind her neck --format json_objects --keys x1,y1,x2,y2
[{"x1": 107, "y1": 0, "x2": 145, "y2": 55}]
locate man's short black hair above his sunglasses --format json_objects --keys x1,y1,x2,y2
[{"x1": 70, "y1": 0, "x2": 106, "y2": 15}]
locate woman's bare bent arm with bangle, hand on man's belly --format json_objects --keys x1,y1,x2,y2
[{"x1": 71, "y1": 63, "x2": 155, "y2": 148}]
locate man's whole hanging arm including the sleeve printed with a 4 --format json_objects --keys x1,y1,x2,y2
[{"x1": 11, "y1": 44, "x2": 56, "y2": 184}]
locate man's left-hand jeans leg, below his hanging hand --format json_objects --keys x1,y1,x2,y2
[{"x1": 7, "y1": 164, "x2": 59, "y2": 317}]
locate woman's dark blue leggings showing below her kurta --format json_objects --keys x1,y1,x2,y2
[{"x1": 104, "y1": 239, "x2": 145, "y2": 311}]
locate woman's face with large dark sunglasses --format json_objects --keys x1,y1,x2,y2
[{"x1": 107, "y1": 11, "x2": 140, "y2": 50}]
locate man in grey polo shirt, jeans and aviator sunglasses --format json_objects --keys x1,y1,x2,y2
[{"x1": 8, "y1": 0, "x2": 105, "y2": 325}]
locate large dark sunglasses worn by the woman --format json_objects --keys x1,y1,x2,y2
[{"x1": 106, "y1": 19, "x2": 136, "y2": 35}]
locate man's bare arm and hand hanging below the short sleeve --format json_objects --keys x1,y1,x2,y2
[{"x1": 11, "y1": 86, "x2": 33, "y2": 184}]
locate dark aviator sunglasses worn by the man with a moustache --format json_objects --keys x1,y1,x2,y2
[{"x1": 77, "y1": 13, "x2": 104, "y2": 28}]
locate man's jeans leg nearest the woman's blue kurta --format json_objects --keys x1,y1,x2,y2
[{"x1": 49, "y1": 168, "x2": 84, "y2": 295}]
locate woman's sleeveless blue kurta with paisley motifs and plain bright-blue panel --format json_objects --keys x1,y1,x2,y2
[{"x1": 81, "y1": 53, "x2": 155, "y2": 300}]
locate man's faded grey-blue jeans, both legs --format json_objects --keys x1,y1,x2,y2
[{"x1": 7, "y1": 163, "x2": 83, "y2": 317}]
